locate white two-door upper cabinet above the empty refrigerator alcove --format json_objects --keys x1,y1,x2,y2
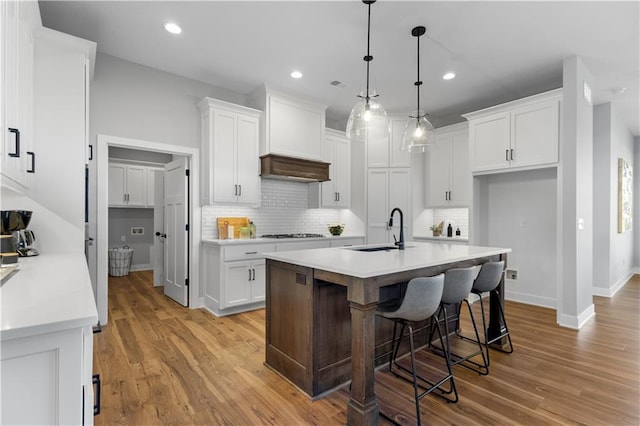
[{"x1": 463, "y1": 89, "x2": 562, "y2": 172}]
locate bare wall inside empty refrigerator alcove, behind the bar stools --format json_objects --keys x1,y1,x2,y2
[{"x1": 474, "y1": 168, "x2": 558, "y2": 308}]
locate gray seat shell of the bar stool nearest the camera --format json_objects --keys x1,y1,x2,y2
[{"x1": 382, "y1": 274, "x2": 444, "y2": 321}]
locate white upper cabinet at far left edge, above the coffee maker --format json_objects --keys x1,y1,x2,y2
[{"x1": 0, "y1": 1, "x2": 40, "y2": 189}]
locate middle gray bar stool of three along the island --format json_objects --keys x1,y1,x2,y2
[{"x1": 429, "y1": 266, "x2": 489, "y2": 375}]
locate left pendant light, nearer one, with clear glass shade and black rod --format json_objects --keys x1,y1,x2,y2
[{"x1": 346, "y1": 0, "x2": 389, "y2": 140}]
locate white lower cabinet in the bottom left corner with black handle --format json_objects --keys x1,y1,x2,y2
[{"x1": 0, "y1": 327, "x2": 94, "y2": 425}]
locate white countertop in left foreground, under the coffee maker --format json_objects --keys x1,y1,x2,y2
[{"x1": 0, "y1": 253, "x2": 98, "y2": 340}]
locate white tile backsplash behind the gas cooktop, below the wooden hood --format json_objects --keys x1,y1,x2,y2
[{"x1": 202, "y1": 179, "x2": 340, "y2": 239}]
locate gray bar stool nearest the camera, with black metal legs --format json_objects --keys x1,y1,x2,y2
[{"x1": 376, "y1": 274, "x2": 458, "y2": 425}]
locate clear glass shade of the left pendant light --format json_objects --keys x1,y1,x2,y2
[{"x1": 346, "y1": 93, "x2": 389, "y2": 140}]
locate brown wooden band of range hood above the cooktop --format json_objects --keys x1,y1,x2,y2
[{"x1": 260, "y1": 154, "x2": 330, "y2": 182}]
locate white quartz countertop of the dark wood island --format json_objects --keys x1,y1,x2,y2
[{"x1": 265, "y1": 241, "x2": 511, "y2": 278}]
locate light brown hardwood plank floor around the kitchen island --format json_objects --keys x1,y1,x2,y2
[{"x1": 94, "y1": 271, "x2": 640, "y2": 425}]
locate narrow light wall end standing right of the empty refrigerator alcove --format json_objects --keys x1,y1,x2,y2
[{"x1": 557, "y1": 56, "x2": 595, "y2": 329}]
